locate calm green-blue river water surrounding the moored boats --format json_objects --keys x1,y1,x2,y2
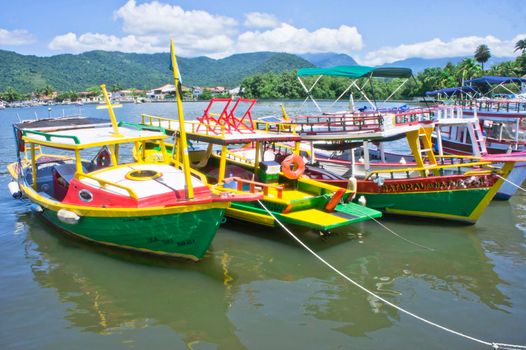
[{"x1": 0, "y1": 102, "x2": 526, "y2": 350}]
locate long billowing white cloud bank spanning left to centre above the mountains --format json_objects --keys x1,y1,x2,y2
[{"x1": 48, "y1": 0, "x2": 363, "y2": 58}]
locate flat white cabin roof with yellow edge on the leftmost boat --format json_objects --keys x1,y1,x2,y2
[{"x1": 16, "y1": 118, "x2": 168, "y2": 149}]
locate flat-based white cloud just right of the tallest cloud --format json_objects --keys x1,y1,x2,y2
[{"x1": 236, "y1": 23, "x2": 363, "y2": 53}]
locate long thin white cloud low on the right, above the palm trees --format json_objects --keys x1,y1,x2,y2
[{"x1": 359, "y1": 34, "x2": 526, "y2": 65}]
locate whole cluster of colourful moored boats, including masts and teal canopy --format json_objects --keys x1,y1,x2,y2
[{"x1": 8, "y1": 47, "x2": 526, "y2": 260}]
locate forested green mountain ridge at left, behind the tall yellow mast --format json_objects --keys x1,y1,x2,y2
[{"x1": 0, "y1": 50, "x2": 312, "y2": 92}]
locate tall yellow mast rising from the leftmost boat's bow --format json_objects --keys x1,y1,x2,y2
[{"x1": 170, "y1": 39, "x2": 194, "y2": 198}]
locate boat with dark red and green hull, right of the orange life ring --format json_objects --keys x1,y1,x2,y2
[{"x1": 256, "y1": 105, "x2": 518, "y2": 223}]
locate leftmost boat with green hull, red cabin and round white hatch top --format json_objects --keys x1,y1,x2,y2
[{"x1": 8, "y1": 46, "x2": 261, "y2": 260}]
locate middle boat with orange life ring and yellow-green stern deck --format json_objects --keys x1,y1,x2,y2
[{"x1": 138, "y1": 99, "x2": 381, "y2": 232}]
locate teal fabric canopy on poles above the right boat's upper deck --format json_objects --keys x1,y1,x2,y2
[{"x1": 296, "y1": 66, "x2": 413, "y2": 79}]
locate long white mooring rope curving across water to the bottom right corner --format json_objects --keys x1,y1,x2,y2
[{"x1": 258, "y1": 200, "x2": 526, "y2": 350}]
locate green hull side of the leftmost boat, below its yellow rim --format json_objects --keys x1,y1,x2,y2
[{"x1": 40, "y1": 203, "x2": 227, "y2": 260}]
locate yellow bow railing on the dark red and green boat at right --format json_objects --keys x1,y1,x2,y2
[{"x1": 365, "y1": 160, "x2": 496, "y2": 180}]
